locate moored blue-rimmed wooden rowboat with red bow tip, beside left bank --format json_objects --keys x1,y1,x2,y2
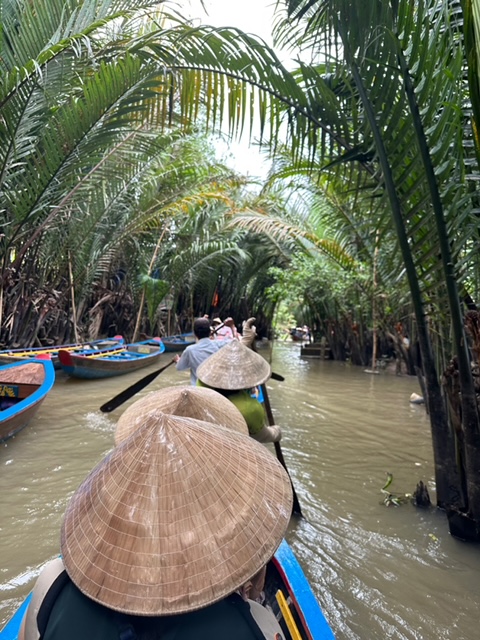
[{"x1": 58, "y1": 338, "x2": 165, "y2": 380}]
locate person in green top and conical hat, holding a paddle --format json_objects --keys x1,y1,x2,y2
[{"x1": 197, "y1": 340, "x2": 282, "y2": 443}]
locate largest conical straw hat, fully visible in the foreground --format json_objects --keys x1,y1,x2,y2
[{"x1": 61, "y1": 410, "x2": 292, "y2": 616}]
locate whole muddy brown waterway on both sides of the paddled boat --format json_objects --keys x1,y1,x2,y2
[{"x1": 0, "y1": 344, "x2": 480, "y2": 640}]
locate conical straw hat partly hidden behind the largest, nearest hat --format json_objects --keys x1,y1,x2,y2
[{"x1": 115, "y1": 386, "x2": 248, "y2": 445}]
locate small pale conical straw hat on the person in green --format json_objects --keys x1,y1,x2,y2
[{"x1": 197, "y1": 340, "x2": 271, "y2": 391}]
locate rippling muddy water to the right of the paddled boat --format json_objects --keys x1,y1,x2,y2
[{"x1": 270, "y1": 348, "x2": 480, "y2": 640}]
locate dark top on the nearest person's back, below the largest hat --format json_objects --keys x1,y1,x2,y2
[{"x1": 37, "y1": 571, "x2": 274, "y2": 640}]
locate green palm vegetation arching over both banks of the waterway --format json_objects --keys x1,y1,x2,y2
[{"x1": 0, "y1": 0, "x2": 480, "y2": 539}]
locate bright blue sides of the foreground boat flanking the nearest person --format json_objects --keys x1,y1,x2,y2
[{"x1": 0, "y1": 540, "x2": 334, "y2": 640}]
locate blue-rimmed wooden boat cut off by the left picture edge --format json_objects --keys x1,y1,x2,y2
[{"x1": 0, "y1": 358, "x2": 55, "y2": 442}]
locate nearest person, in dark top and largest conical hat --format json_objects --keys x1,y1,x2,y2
[{"x1": 18, "y1": 408, "x2": 292, "y2": 640}]
